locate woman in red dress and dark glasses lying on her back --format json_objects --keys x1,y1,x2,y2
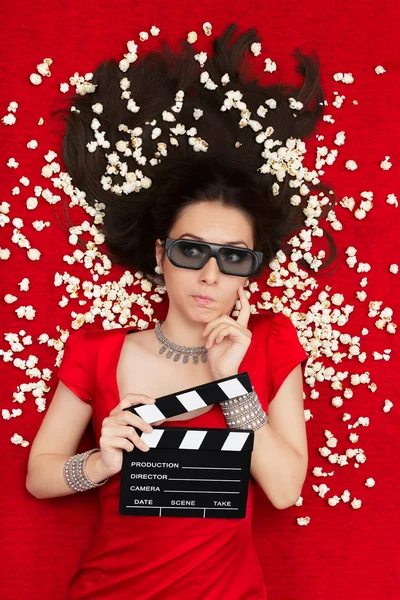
[{"x1": 27, "y1": 25, "x2": 338, "y2": 600}]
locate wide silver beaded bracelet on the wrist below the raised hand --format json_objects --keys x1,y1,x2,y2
[{"x1": 220, "y1": 388, "x2": 268, "y2": 431}]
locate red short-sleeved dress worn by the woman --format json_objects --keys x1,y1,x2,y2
[{"x1": 59, "y1": 313, "x2": 307, "y2": 600}]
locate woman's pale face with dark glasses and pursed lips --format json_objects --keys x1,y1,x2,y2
[{"x1": 156, "y1": 202, "x2": 253, "y2": 323}]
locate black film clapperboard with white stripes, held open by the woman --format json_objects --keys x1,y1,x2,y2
[{"x1": 119, "y1": 372, "x2": 254, "y2": 519}]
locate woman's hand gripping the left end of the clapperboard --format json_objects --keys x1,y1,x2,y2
[{"x1": 100, "y1": 393, "x2": 155, "y2": 477}]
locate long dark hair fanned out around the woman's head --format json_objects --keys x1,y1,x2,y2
[{"x1": 53, "y1": 24, "x2": 337, "y2": 284}]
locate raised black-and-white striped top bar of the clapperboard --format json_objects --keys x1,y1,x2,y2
[{"x1": 124, "y1": 372, "x2": 253, "y2": 423}]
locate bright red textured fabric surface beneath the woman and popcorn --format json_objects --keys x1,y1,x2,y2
[{"x1": 0, "y1": 0, "x2": 400, "y2": 600}]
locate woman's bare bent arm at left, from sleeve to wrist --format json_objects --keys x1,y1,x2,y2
[{"x1": 26, "y1": 381, "x2": 109, "y2": 498}]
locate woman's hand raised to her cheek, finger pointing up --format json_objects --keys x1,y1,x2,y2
[{"x1": 203, "y1": 286, "x2": 252, "y2": 379}]
